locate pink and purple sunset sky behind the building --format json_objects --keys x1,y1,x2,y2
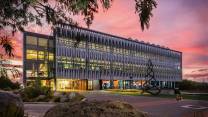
[{"x1": 7, "y1": 0, "x2": 208, "y2": 81}]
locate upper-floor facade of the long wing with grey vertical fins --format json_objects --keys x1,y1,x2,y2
[{"x1": 56, "y1": 23, "x2": 182, "y2": 81}]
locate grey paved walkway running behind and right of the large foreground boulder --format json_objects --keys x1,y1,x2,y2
[{"x1": 25, "y1": 92, "x2": 208, "y2": 117}]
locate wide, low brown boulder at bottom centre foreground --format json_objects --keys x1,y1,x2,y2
[{"x1": 44, "y1": 101, "x2": 147, "y2": 117}]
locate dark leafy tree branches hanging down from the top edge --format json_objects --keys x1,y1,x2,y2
[{"x1": 0, "y1": 0, "x2": 157, "y2": 33}]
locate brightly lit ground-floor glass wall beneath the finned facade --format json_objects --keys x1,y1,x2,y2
[{"x1": 27, "y1": 79, "x2": 176, "y2": 91}]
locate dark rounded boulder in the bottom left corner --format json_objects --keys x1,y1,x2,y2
[{"x1": 0, "y1": 91, "x2": 24, "y2": 117}]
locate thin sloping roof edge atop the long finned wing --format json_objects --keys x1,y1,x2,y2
[{"x1": 57, "y1": 23, "x2": 182, "y2": 53}]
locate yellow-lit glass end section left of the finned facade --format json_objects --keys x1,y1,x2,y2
[{"x1": 24, "y1": 33, "x2": 55, "y2": 86}]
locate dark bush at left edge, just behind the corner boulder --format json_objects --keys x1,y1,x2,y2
[{"x1": 0, "y1": 76, "x2": 20, "y2": 90}]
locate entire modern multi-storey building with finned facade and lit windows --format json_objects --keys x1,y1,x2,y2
[{"x1": 23, "y1": 24, "x2": 182, "y2": 91}]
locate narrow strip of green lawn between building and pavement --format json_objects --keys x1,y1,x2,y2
[{"x1": 106, "y1": 89, "x2": 208, "y2": 101}]
